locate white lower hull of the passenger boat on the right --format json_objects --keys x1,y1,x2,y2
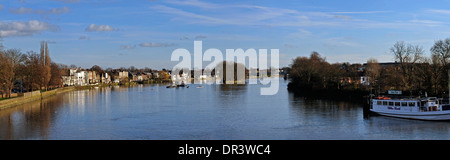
[{"x1": 371, "y1": 110, "x2": 450, "y2": 121}]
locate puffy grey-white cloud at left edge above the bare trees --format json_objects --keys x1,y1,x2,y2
[{"x1": 0, "y1": 20, "x2": 58, "y2": 38}]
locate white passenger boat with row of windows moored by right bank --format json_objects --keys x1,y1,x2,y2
[{"x1": 370, "y1": 97, "x2": 450, "y2": 121}]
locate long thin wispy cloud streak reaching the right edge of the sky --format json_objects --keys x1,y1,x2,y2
[{"x1": 156, "y1": 0, "x2": 450, "y2": 29}]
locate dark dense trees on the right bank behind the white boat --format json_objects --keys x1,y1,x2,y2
[{"x1": 289, "y1": 38, "x2": 450, "y2": 97}]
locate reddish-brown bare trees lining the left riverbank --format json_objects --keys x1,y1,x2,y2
[{"x1": 0, "y1": 41, "x2": 68, "y2": 98}]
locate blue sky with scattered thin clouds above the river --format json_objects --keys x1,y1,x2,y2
[{"x1": 0, "y1": 0, "x2": 450, "y2": 69}]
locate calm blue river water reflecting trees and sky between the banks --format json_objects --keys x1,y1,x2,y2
[{"x1": 0, "y1": 79, "x2": 450, "y2": 140}]
